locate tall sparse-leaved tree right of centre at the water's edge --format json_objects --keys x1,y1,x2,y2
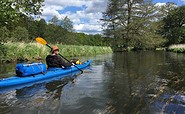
[{"x1": 102, "y1": 0, "x2": 168, "y2": 48}]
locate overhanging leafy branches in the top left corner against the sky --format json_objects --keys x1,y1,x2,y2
[{"x1": 0, "y1": 0, "x2": 44, "y2": 26}]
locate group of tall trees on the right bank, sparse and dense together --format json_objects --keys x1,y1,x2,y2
[{"x1": 101, "y1": 0, "x2": 185, "y2": 49}]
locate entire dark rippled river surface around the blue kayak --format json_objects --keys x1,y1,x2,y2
[{"x1": 0, "y1": 51, "x2": 185, "y2": 114}]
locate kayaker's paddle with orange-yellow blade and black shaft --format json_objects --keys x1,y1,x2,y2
[{"x1": 36, "y1": 37, "x2": 83, "y2": 74}]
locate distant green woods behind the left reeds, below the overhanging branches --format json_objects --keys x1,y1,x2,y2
[{"x1": 0, "y1": 16, "x2": 110, "y2": 46}]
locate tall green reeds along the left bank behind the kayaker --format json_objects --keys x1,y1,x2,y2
[{"x1": 0, "y1": 42, "x2": 113, "y2": 63}]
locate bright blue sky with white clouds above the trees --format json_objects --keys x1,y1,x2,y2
[{"x1": 41, "y1": 0, "x2": 185, "y2": 34}]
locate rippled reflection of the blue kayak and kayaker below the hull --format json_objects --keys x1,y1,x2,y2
[{"x1": 0, "y1": 77, "x2": 75, "y2": 114}]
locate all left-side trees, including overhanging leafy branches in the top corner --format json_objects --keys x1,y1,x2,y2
[{"x1": 0, "y1": 0, "x2": 110, "y2": 46}]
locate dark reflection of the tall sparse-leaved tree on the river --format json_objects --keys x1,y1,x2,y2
[{"x1": 102, "y1": 52, "x2": 163, "y2": 114}]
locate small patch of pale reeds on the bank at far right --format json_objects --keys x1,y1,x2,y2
[{"x1": 168, "y1": 44, "x2": 185, "y2": 53}]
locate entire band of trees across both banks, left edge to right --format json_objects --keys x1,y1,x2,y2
[{"x1": 0, "y1": 0, "x2": 185, "y2": 49}]
